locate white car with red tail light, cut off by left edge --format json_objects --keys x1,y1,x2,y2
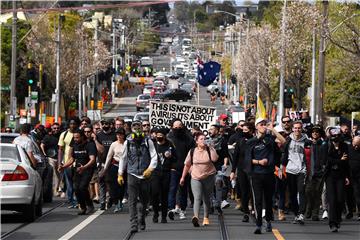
[{"x1": 0, "y1": 143, "x2": 43, "y2": 222}]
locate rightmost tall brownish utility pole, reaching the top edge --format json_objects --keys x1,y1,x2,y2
[{"x1": 316, "y1": 0, "x2": 329, "y2": 123}]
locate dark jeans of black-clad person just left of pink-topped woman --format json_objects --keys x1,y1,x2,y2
[{"x1": 168, "y1": 171, "x2": 190, "y2": 211}]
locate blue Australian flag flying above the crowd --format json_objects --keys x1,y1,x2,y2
[{"x1": 198, "y1": 58, "x2": 221, "y2": 87}]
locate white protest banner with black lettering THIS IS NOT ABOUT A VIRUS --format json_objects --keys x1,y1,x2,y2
[{"x1": 150, "y1": 102, "x2": 216, "y2": 135}]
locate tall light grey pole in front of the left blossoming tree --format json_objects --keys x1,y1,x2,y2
[{"x1": 55, "y1": 14, "x2": 64, "y2": 122}]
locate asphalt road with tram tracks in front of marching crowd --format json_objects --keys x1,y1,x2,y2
[{"x1": 1, "y1": 199, "x2": 360, "y2": 240}]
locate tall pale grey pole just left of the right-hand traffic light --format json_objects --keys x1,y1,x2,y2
[{"x1": 278, "y1": 0, "x2": 286, "y2": 122}]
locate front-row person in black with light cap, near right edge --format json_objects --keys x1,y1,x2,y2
[{"x1": 321, "y1": 128, "x2": 350, "y2": 232}]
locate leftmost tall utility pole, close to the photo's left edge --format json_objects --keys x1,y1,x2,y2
[{"x1": 10, "y1": 0, "x2": 17, "y2": 116}]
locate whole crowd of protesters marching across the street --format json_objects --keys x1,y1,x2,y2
[{"x1": 8, "y1": 114, "x2": 360, "y2": 234}]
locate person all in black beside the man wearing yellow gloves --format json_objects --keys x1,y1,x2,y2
[{"x1": 151, "y1": 128, "x2": 176, "y2": 223}]
